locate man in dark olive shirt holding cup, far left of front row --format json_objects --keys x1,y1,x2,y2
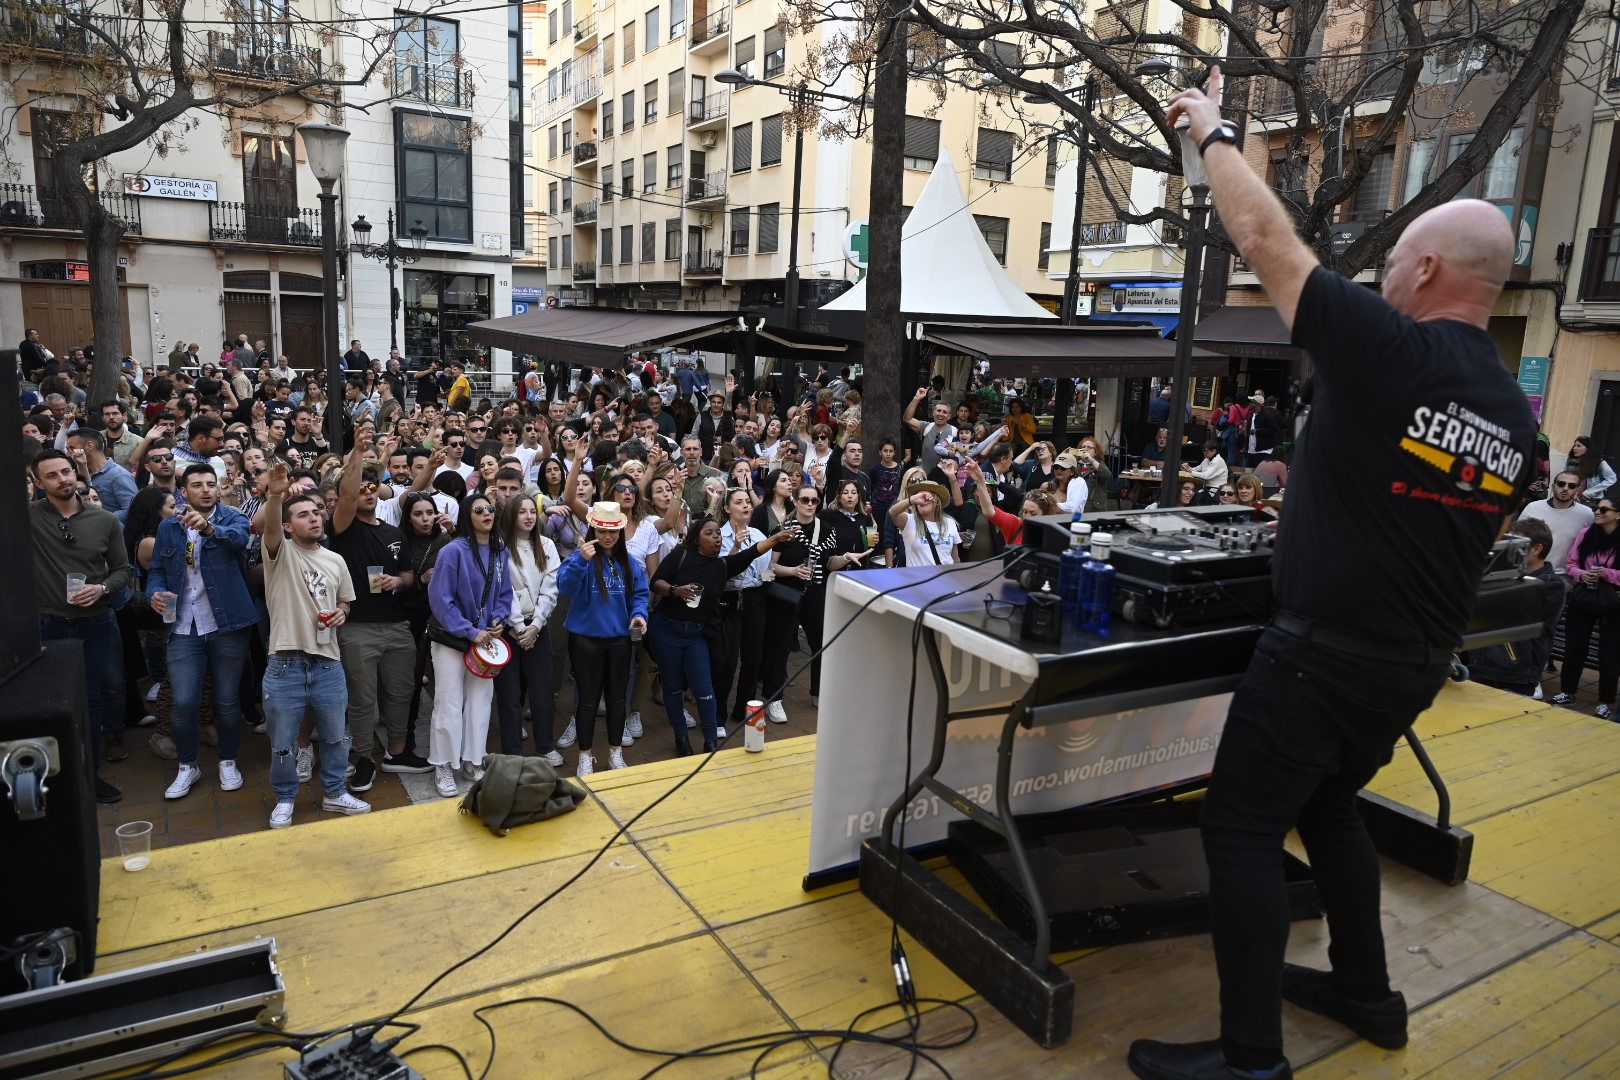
[{"x1": 28, "y1": 450, "x2": 134, "y2": 803}]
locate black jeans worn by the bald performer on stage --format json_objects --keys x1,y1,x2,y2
[{"x1": 1202, "y1": 630, "x2": 1448, "y2": 1057}]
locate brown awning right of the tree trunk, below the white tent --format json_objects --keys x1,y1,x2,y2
[{"x1": 922, "y1": 322, "x2": 1226, "y2": 379}]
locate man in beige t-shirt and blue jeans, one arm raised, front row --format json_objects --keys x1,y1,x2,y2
[{"x1": 264, "y1": 463, "x2": 371, "y2": 829}]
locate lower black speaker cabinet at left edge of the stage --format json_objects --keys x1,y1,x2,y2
[{"x1": 0, "y1": 641, "x2": 100, "y2": 994}]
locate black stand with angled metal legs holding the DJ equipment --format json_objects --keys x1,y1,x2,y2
[{"x1": 835, "y1": 540, "x2": 1541, "y2": 1048}]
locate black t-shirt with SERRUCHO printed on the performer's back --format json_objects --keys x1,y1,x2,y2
[{"x1": 1272, "y1": 267, "x2": 1536, "y2": 648}]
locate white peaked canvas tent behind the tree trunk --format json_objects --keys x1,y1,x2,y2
[{"x1": 821, "y1": 146, "x2": 1056, "y2": 319}]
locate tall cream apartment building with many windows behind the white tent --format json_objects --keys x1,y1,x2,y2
[{"x1": 535, "y1": 0, "x2": 1058, "y2": 318}]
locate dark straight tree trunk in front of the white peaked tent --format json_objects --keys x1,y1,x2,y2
[{"x1": 860, "y1": 0, "x2": 907, "y2": 446}]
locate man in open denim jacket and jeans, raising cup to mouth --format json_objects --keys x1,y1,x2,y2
[{"x1": 147, "y1": 463, "x2": 259, "y2": 798}]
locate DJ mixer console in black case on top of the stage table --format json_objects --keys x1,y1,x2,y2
[{"x1": 1003, "y1": 507, "x2": 1528, "y2": 630}]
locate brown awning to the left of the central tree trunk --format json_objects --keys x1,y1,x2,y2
[{"x1": 467, "y1": 308, "x2": 852, "y2": 368}]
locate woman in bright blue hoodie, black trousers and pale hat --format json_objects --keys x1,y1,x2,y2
[{"x1": 557, "y1": 502, "x2": 646, "y2": 776}]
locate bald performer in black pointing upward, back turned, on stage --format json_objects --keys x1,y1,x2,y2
[{"x1": 1128, "y1": 68, "x2": 1536, "y2": 1080}]
